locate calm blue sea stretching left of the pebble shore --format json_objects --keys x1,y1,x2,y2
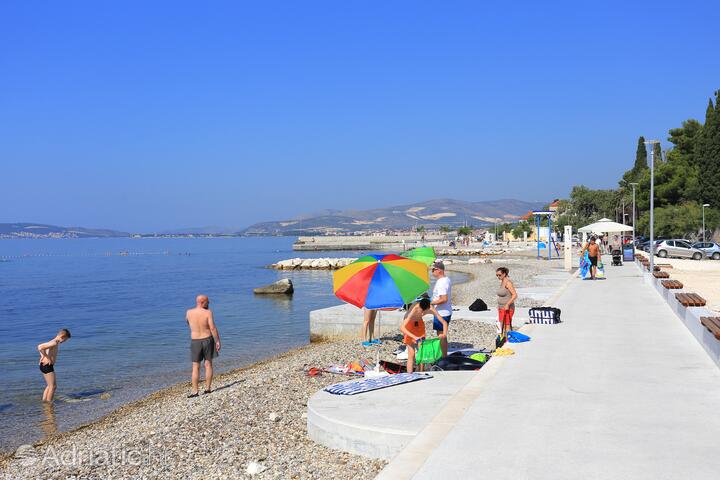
[{"x1": 0, "y1": 237, "x2": 464, "y2": 450}]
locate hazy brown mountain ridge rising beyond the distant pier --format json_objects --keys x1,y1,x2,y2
[{"x1": 241, "y1": 199, "x2": 544, "y2": 235}]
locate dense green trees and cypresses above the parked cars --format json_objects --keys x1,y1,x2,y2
[{"x1": 556, "y1": 91, "x2": 720, "y2": 239}]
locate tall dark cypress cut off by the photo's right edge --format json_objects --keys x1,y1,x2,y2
[{"x1": 696, "y1": 90, "x2": 720, "y2": 208}]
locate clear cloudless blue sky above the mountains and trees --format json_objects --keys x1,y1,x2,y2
[{"x1": 0, "y1": 1, "x2": 720, "y2": 231}]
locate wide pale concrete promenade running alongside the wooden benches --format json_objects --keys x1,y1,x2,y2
[{"x1": 378, "y1": 262, "x2": 720, "y2": 480}]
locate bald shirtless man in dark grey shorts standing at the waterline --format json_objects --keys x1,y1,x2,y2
[{"x1": 185, "y1": 295, "x2": 220, "y2": 398}]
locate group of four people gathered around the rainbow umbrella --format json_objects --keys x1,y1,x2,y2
[{"x1": 362, "y1": 260, "x2": 517, "y2": 372}]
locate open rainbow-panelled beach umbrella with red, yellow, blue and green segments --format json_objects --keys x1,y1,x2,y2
[{"x1": 333, "y1": 254, "x2": 430, "y2": 309}]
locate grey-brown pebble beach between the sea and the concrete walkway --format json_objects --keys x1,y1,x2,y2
[{"x1": 0, "y1": 253, "x2": 550, "y2": 479}]
